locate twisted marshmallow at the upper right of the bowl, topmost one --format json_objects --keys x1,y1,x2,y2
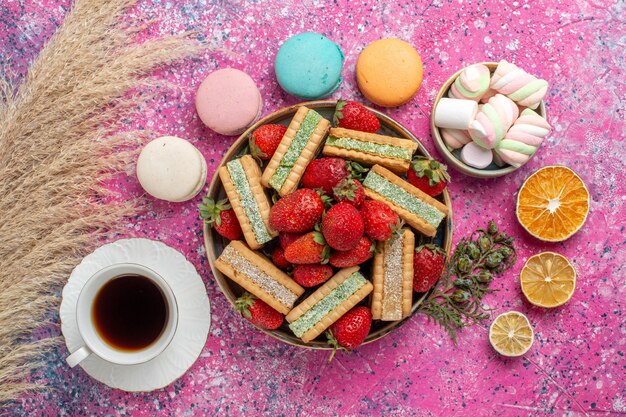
[{"x1": 491, "y1": 60, "x2": 548, "y2": 109}]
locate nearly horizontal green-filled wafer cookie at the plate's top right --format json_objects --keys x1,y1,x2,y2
[{"x1": 322, "y1": 127, "x2": 417, "y2": 175}]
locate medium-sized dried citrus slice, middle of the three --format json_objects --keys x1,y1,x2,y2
[{"x1": 520, "y1": 252, "x2": 576, "y2": 308}]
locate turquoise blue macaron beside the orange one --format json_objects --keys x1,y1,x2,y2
[{"x1": 274, "y1": 32, "x2": 343, "y2": 100}]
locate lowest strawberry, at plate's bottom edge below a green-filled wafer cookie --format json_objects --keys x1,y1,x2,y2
[{"x1": 326, "y1": 306, "x2": 372, "y2": 359}]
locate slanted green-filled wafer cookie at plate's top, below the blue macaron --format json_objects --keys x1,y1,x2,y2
[{"x1": 261, "y1": 106, "x2": 330, "y2": 197}]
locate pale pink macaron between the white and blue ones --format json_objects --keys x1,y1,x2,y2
[{"x1": 196, "y1": 68, "x2": 263, "y2": 136}]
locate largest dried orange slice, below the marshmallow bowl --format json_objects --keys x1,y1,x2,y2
[{"x1": 516, "y1": 166, "x2": 589, "y2": 242}]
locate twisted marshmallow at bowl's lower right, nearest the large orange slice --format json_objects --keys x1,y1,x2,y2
[{"x1": 495, "y1": 109, "x2": 550, "y2": 167}]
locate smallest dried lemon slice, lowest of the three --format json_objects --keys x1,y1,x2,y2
[{"x1": 489, "y1": 311, "x2": 535, "y2": 356}]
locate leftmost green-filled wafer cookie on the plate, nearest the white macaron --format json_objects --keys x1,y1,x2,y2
[{"x1": 219, "y1": 155, "x2": 278, "y2": 249}]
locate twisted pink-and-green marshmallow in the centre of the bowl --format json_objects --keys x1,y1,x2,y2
[{"x1": 469, "y1": 94, "x2": 519, "y2": 149}]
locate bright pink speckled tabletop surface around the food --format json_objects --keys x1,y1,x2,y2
[{"x1": 0, "y1": 0, "x2": 626, "y2": 416}]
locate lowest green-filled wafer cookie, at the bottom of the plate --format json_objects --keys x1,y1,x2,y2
[{"x1": 286, "y1": 266, "x2": 372, "y2": 343}]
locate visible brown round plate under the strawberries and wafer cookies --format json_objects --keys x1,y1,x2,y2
[{"x1": 203, "y1": 100, "x2": 452, "y2": 349}]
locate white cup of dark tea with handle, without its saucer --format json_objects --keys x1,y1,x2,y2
[{"x1": 66, "y1": 263, "x2": 178, "y2": 367}]
